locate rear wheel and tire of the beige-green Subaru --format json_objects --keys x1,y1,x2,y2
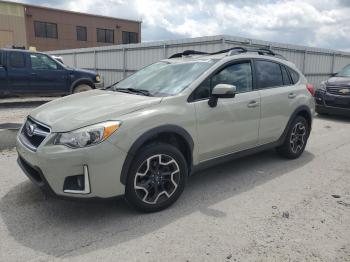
[{"x1": 277, "y1": 116, "x2": 310, "y2": 159}]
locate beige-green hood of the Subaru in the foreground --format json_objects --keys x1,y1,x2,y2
[{"x1": 30, "y1": 90, "x2": 162, "y2": 132}]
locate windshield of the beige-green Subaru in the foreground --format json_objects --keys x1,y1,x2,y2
[{"x1": 111, "y1": 59, "x2": 216, "y2": 96}]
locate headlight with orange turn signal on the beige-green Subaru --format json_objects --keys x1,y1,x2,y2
[{"x1": 54, "y1": 121, "x2": 121, "y2": 148}]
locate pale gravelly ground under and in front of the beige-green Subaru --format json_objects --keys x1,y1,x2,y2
[{"x1": 0, "y1": 117, "x2": 350, "y2": 261}]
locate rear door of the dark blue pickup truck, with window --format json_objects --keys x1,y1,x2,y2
[{"x1": 7, "y1": 51, "x2": 31, "y2": 94}]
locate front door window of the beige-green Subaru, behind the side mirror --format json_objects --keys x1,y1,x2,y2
[{"x1": 193, "y1": 62, "x2": 253, "y2": 100}]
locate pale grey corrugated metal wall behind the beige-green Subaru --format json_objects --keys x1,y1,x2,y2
[{"x1": 48, "y1": 35, "x2": 350, "y2": 86}]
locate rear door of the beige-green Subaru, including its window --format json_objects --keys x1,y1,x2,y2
[{"x1": 254, "y1": 59, "x2": 297, "y2": 145}]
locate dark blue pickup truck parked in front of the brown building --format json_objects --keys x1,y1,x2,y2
[{"x1": 0, "y1": 49, "x2": 102, "y2": 96}]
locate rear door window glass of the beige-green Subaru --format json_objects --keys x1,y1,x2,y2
[{"x1": 255, "y1": 60, "x2": 283, "y2": 88}]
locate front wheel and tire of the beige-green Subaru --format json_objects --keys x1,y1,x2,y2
[{"x1": 125, "y1": 143, "x2": 188, "y2": 213}]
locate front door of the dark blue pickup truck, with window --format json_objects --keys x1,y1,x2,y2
[{"x1": 30, "y1": 53, "x2": 70, "y2": 94}]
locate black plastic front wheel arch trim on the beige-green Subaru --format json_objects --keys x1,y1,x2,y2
[{"x1": 120, "y1": 125, "x2": 194, "y2": 185}]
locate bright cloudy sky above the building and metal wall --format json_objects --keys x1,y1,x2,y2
[{"x1": 9, "y1": 0, "x2": 350, "y2": 51}]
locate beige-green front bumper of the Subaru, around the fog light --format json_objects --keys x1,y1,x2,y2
[{"x1": 17, "y1": 133, "x2": 127, "y2": 198}]
